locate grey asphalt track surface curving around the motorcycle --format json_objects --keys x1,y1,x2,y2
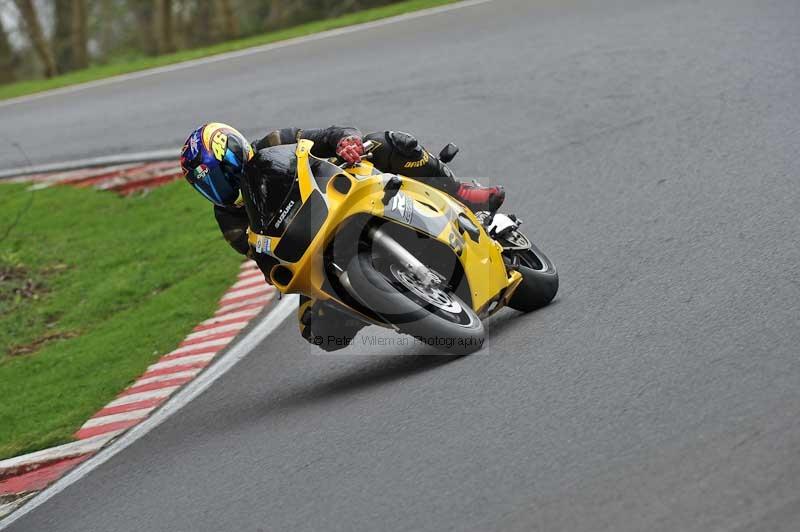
[{"x1": 0, "y1": 0, "x2": 800, "y2": 532}]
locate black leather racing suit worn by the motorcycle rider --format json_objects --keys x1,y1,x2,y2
[{"x1": 214, "y1": 126, "x2": 458, "y2": 351}]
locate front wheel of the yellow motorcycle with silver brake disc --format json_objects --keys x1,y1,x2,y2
[{"x1": 346, "y1": 251, "x2": 485, "y2": 355}]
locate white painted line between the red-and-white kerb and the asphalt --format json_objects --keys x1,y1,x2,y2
[{"x1": 0, "y1": 295, "x2": 298, "y2": 530}]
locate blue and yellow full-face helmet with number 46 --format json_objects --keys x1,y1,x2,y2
[{"x1": 181, "y1": 122, "x2": 253, "y2": 207}]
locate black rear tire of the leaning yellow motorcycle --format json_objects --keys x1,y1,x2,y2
[{"x1": 508, "y1": 244, "x2": 558, "y2": 312}]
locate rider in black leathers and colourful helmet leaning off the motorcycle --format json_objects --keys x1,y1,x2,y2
[{"x1": 181, "y1": 122, "x2": 505, "y2": 351}]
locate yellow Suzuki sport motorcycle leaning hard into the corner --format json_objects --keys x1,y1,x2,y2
[{"x1": 242, "y1": 140, "x2": 558, "y2": 354}]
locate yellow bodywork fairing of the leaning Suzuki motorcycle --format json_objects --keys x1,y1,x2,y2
[{"x1": 248, "y1": 140, "x2": 522, "y2": 316}]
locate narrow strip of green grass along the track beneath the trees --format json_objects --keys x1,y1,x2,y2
[{"x1": 0, "y1": 0, "x2": 455, "y2": 100}]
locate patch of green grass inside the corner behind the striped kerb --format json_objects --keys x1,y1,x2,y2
[{"x1": 0, "y1": 182, "x2": 241, "y2": 458}]
